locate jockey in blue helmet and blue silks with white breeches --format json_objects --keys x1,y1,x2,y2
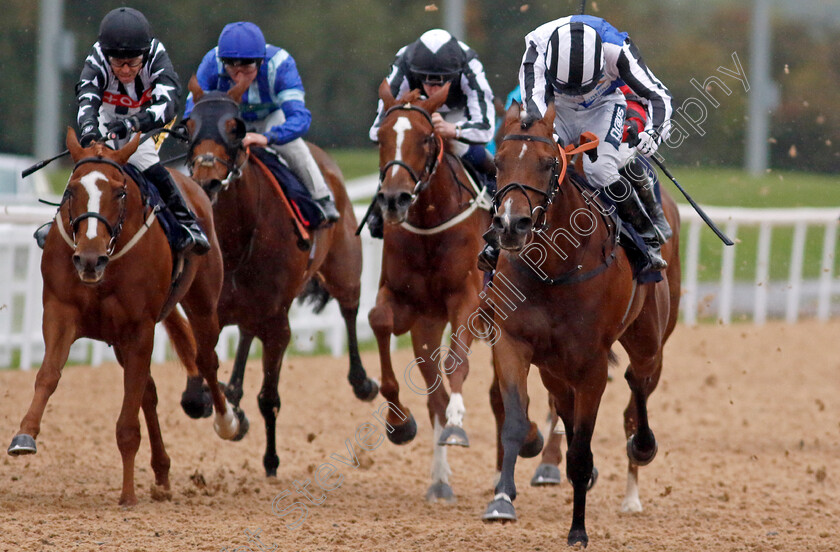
[{"x1": 184, "y1": 21, "x2": 339, "y2": 222}]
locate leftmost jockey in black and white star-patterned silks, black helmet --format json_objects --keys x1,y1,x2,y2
[{"x1": 72, "y1": 8, "x2": 210, "y2": 255}]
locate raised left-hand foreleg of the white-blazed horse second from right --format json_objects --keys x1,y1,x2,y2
[{"x1": 368, "y1": 287, "x2": 417, "y2": 445}]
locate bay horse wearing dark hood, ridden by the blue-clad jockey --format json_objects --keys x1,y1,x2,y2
[{"x1": 187, "y1": 76, "x2": 379, "y2": 477}]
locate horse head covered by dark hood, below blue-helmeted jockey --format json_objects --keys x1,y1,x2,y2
[{"x1": 186, "y1": 75, "x2": 247, "y2": 203}]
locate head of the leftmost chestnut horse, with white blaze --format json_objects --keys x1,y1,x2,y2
[{"x1": 60, "y1": 128, "x2": 140, "y2": 284}]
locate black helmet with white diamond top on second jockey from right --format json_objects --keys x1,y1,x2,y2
[{"x1": 406, "y1": 29, "x2": 466, "y2": 83}]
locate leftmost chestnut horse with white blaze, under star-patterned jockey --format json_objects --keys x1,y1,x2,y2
[{"x1": 8, "y1": 129, "x2": 244, "y2": 506}]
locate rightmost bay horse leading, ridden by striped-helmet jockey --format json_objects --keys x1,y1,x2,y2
[{"x1": 484, "y1": 103, "x2": 680, "y2": 546}]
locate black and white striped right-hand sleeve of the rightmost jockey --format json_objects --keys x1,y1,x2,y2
[{"x1": 616, "y1": 38, "x2": 673, "y2": 135}]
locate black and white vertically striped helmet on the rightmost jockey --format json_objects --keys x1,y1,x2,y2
[{"x1": 545, "y1": 22, "x2": 604, "y2": 95}]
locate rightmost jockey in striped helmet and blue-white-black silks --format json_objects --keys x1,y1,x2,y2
[{"x1": 482, "y1": 15, "x2": 672, "y2": 271}]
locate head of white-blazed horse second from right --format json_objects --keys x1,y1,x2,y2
[{"x1": 376, "y1": 80, "x2": 449, "y2": 224}]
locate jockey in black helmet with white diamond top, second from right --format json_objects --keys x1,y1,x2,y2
[{"x1": 367, "y1": 29, "x2": 496, "y2": 238}]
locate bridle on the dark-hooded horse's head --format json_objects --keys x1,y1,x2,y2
[{"x1": 187, "y1": 95, "x2": 248, "y2": 197}]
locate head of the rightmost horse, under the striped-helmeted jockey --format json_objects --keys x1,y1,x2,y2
[{"x1": 492, "y1": 102, "x2": 561, "y2": 251}]
